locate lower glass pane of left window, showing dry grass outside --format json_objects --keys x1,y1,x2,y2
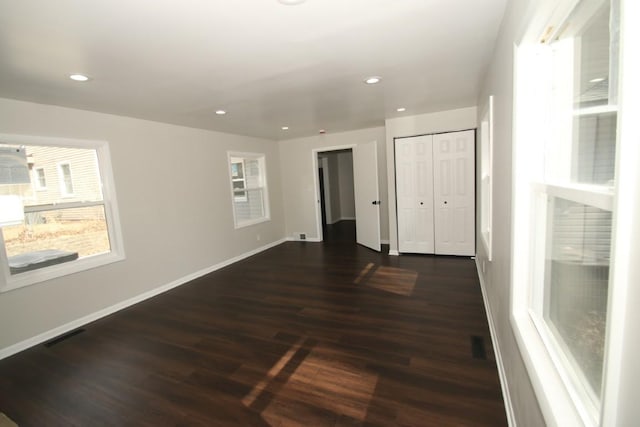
[{"x1": 2, "y1": 205, "x2": 111, "y2": 274}]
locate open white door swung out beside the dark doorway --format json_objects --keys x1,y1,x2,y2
[{"x1": 353, "y1": 141, "x2": 380, "y2": 252}]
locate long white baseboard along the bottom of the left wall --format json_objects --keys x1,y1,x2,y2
[{"x1": 0, "y1": 239, "x2": 286, "y2": 360}]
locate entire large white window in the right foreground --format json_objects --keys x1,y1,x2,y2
[{"x1": 512, "y1": 0, "x2": 620, "y2": 425}]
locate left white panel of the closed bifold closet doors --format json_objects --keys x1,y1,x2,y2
[{"x1": 395, "y1": 135, "x2": 435, "y2": 254}]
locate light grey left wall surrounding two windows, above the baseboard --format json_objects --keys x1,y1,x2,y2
[{"x1": 0, "y1": 99, "x2": 284, "y2": 351}]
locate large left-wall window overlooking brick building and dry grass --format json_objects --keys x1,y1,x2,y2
[{"x1": 0, "y1": 135, "x2": 124, "y2": 291}]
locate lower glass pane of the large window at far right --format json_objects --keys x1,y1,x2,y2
[{"x1": 544, "y1": 198, "x2": 612, "y2": 396}]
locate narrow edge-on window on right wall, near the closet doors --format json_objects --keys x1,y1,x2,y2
[{"x1": 480, "y1": 96, "x2": 493, "y2": 261}]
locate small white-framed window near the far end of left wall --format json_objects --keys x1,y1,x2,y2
[{"x1": 229, "y1": 153, "x2": 269, "y2": 228}]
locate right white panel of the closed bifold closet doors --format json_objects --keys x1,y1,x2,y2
[{"x1": 433, "y1": 130, "x2": 475, "y2": 256}]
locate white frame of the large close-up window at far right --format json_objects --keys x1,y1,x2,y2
[{"x1": 510, "y1": 0, "x2": 640, "y2": 426}]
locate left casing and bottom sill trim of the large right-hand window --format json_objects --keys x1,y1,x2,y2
[{"x1": 511, "y1": 39, "x2": 594, "y2": 427}]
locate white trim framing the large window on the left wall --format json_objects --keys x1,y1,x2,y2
[{"x1": 0, "y1": 134, "x2": 125, "y2": 293}]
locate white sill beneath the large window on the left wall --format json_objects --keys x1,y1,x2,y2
[{"x1": 0, "y1": 252, "x2": 125, "y2": 293}]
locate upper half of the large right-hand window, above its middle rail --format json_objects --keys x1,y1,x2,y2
[{"x1": 549, "y1": 1, "x2": 618, "y2": 186}]
